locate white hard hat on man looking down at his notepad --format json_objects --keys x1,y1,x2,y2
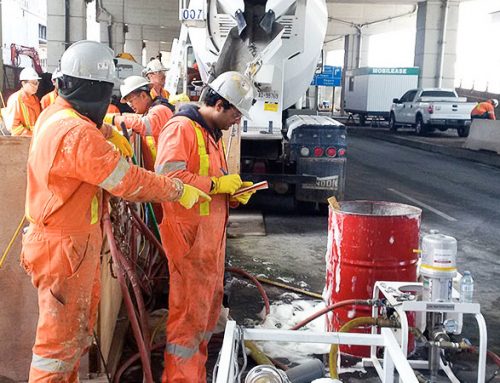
[{"x1": 208, "y1": 72, "x2": 255, "y2": 118}]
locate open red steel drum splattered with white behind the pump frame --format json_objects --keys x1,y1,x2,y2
[{"x1": 324, "y1": 201, "x2": 422, "y2": 357}]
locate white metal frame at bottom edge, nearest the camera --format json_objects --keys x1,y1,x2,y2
[{"x1": 215, "y1": 321, "x2": 424, "y2": 383}]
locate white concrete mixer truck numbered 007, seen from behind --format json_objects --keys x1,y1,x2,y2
[{"x1": 175, "y1": 0, "x2": 346, "y2": 207}]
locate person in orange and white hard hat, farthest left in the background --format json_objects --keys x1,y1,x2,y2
[{"x1": 2, "y1": 68, "x2": 41, "y2": 136}]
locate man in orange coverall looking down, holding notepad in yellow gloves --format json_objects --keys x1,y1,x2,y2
[{"x1": 155, "y1": 72, "x2": 254, "y2": 383}]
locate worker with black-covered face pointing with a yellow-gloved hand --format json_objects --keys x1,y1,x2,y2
[{"x1": 21, "y1": 41, "x2": 210, "y2": 383}]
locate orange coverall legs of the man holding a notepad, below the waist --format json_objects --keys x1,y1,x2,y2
[{"x1": 160, "y1": 224, "x2": 225, "y2": 383}]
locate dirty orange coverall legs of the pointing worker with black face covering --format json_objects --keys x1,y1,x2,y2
[{"x1": 25, "y1": 231, "x2": 102, "y2": 383}]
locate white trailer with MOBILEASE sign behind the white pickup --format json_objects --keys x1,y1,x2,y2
[{"x1": 344, "y1": 67, "x2": 419, "y2": 125}]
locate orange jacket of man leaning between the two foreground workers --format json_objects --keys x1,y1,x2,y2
[{"x1": 113, "y1": 104, "x2": 173, "y2": 144}]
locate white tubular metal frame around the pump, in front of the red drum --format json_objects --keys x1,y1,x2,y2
[{"x1": 372, "y1": 281, "x2": 488, "y2": 383}]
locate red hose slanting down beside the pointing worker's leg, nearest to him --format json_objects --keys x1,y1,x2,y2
[{"x1": 102, "y1": 211, "x2": 153, "y2": 383}]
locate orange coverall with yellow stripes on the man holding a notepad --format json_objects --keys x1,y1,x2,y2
[{"x1": 155, "y1": 116, "x2": 228, "y2": 383}]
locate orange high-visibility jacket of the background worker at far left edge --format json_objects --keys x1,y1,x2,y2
[{"x1": 3, "y1": 89, "x2": 41, "y2": 136}]
